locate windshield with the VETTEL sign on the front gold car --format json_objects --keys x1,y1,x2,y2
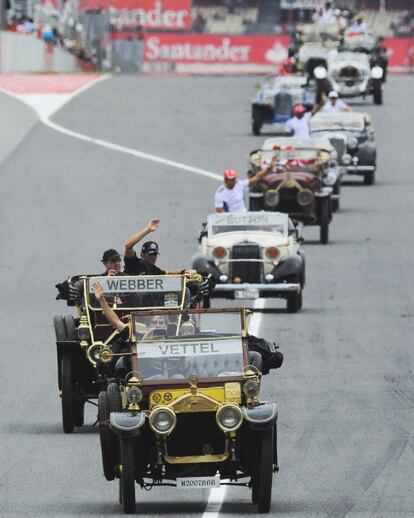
[{"x1": 134, "y1": 310, "x2": 245, "y2": 381}]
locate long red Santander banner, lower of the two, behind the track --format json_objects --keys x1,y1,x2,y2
[{"x1": 144, "y1": 33, "x2": 289, "y2": 65}]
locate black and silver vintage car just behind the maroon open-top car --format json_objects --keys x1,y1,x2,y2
[{"x1": 310, "y1": 112, "x2": 377, "y2": 185}]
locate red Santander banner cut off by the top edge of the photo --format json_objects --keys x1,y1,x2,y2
[{"x1": 78, "y1": 0, "x2": 191, "y2": 30}]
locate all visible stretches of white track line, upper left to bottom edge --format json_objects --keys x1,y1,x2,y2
[{"x1": 0, "y1": 76, "x2": 265, "y2": 518}]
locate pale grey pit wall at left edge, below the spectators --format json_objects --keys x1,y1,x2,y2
[{"x1": 0, "y1": 32, "x2": 81, "y2": 74}]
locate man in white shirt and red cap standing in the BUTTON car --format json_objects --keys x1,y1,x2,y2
[{"x1": 214, "y1": 166, "x2": 269, "y2": 212}]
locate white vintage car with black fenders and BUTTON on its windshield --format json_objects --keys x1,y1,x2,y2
[{"x1": 192, "y1": 211, "x2": 305, "y2": 313}]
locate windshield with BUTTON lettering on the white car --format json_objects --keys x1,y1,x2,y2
[{"x1": 208, "y1": 212, "x2": 288, "y2": 238}]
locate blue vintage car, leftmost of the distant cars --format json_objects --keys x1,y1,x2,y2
[{"x1": 251, "y1": 75, "x2": 315, "y2": 135}]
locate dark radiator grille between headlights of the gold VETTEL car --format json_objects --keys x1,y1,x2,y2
[{"x1": 167, "y1": 412, "x2": 226, "y2": 457}]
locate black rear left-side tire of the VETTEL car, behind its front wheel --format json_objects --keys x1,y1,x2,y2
[{"x1": 98, "y1": 390, "x2": 117, "y2": 480}]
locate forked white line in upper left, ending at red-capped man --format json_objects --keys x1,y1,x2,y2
[{"x1": 0, "y1": 76, "x2": 223, "y2": 182}]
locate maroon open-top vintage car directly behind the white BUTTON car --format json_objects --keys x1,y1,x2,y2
[{"x1": 249, "y1": 137, "x2": 337, "y2": 244}]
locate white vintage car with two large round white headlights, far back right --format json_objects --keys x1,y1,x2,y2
[{"x1": 314, "y1": 52, "x2": 384, "y2": 104}]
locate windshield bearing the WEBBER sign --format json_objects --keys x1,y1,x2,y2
[{"x1": 87, "y1": 275, "x2": 185, "y2": 310}]
